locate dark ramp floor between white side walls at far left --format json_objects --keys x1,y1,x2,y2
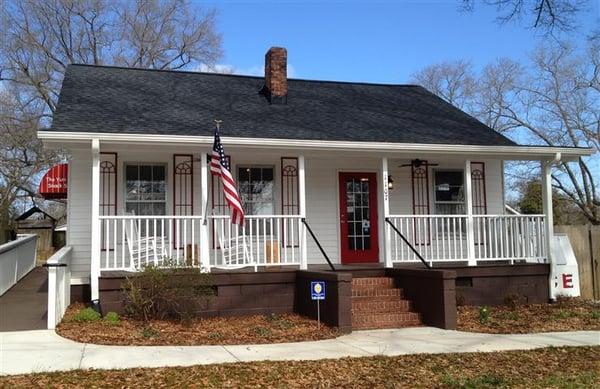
[{"x1": 0, "y1": 267, "x2": 48, "y2": 331}]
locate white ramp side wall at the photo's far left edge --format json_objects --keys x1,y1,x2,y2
[{"x1": 0, "y1": 234, "x2": 38, "y2": 296}]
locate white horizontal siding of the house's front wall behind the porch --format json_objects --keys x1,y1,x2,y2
[{"x1": 68, "y1": 145, "x2": 504, "y2": 279}]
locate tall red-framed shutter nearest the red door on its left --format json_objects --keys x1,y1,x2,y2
[{"x1": 281, "y1": 157, "x2": 300, "y2": 247}]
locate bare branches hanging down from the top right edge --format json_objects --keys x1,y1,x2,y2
[{"x1": 461, "y1": 0, "x2": 590, "y2": 34}]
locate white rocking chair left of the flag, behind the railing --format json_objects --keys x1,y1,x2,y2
[{"x1": 125, "y1": 214, "x2": 167, "y2": 270}]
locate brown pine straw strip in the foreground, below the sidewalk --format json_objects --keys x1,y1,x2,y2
[{"x1": 0, "y1": 347, "x2": 600, "y2": 388}]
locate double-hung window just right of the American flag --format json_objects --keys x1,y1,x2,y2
[{"x1": 238, "y1": 166, "x2": 275, "y2": 215}]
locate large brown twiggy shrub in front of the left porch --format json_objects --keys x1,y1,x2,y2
[{"x1": 124, "y1": 260, "x2": 214, "y2": 322}]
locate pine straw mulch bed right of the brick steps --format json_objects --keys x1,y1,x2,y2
[{"x1": 457, "y1": 298, "x2": 600, "y2": 334}]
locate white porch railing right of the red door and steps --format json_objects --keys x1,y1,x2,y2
[{"x1": 385, "y1": 215, "x2": 547, "y2": 263}]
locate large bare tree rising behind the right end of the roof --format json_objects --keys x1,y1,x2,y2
[{"x1": 414, "y1": 40, "x2": 600, "y2": 224}]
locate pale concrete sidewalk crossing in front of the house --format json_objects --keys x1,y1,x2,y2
[{"x1": 0, "y1": 327, "x2": 600, "y2": 375}]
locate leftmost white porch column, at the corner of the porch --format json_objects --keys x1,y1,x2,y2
[{"x1": 90, "y1": 139, "x2": 100, "y2": 301}]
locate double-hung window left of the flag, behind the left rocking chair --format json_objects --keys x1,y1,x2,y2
[{"x1": 125, "y1": 163, "x2": 167, "y2": 215}]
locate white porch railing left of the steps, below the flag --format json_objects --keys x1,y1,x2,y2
[{"x1": 100, "y1": 215, "x2": 306, "y2": 271}]
